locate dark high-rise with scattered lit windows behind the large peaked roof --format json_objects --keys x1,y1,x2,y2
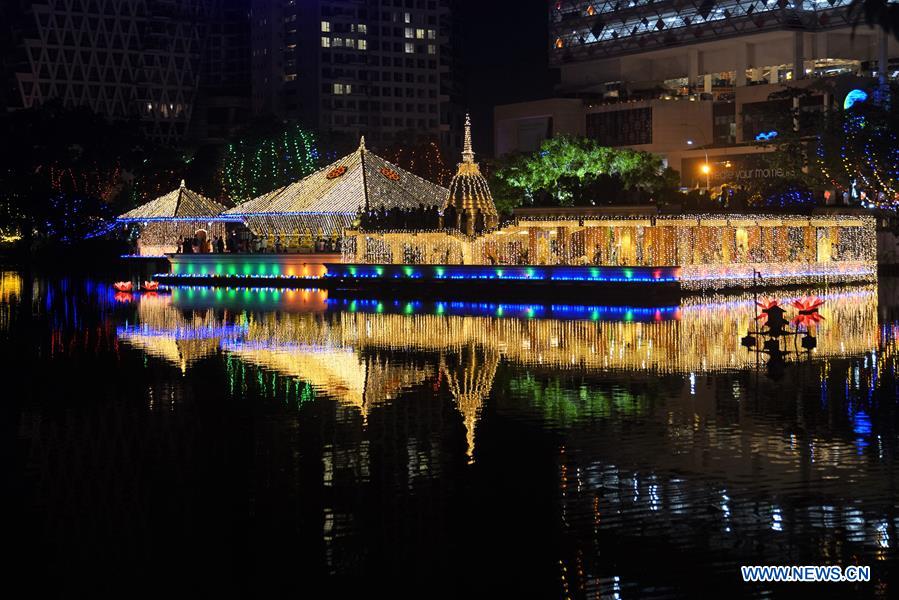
[{"x1": 251, "y1": 0, "x2": 463, "y2": 155}]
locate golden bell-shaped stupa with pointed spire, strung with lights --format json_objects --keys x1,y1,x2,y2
[{"x1": 444, "y1": 115, "x2": 499, "y2": 235}]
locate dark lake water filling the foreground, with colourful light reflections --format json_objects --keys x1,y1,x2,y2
[{"x1": 0, "y1": 272, "x2": 899, "y2": 598}]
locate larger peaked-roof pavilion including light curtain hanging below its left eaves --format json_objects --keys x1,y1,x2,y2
[{"x1": 225, "y1": 138, "x2": 449, "y2": 248}]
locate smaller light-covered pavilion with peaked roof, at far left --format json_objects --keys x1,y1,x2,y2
[{"x1": 116, "y1": 180, "x2": 239, "y2": 256}]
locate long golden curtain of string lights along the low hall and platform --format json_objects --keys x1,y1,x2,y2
[{"x1": 343, "y1": 214, "x2": 877, "y2": 290}]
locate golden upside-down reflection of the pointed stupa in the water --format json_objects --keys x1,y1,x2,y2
[{"x1": 440, "y1": 343, "x2": 499, "y2": 462}]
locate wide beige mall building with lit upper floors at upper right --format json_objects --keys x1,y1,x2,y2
[{"x1": 494, "y1": 0, "x2": 899, "y2": 187}]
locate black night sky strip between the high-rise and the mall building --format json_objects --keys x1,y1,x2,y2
[{"x1": 458, "y1": 0, "x2": 554, "y2": 156}]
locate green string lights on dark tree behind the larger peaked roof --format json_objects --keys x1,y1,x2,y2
[{"x1": 221, "y1": 125, "x2": 321, "y2": 201}]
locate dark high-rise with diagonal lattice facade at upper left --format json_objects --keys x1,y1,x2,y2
[{"x1": 7, "y1": 0, "x2": 249, "y2": 143}]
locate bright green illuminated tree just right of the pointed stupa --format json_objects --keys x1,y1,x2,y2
[{"x1": 493, "y1": 136, "x2": 676, "y2": 206}]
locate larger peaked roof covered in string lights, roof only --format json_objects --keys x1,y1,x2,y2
[{"x1": 225, "y1": 138, "x2": 449, "y2": 217}]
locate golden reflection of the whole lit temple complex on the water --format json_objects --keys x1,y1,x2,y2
[{"x1": 119, "y1": 288, "x2": 878, "y2": 468}]
